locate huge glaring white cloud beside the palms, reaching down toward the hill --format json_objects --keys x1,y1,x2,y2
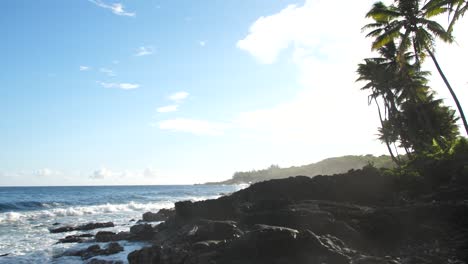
[{"x1": 159, "y1": 0, "x2": 385, "y2": 155}]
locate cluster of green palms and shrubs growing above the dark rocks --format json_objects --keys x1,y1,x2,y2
[{"x1": 357, "y1": 0, "x2": 468, "y2": 188}]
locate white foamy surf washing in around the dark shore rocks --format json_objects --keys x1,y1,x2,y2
[{"x1": 0, "y1": 187, "x2": 236, "y2": 264}]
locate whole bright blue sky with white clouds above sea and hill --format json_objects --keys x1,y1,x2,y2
[{"x1": 0, "y1": 0, "x2": 468, "y2": 185}]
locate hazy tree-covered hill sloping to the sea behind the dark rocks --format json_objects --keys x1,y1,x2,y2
[{"x1": 207, "y1": 155, "x2": 395, "y2": 184}]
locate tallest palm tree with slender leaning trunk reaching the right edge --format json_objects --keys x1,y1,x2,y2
[{"x1": 363, "y1": 0, "x2": 468, "y2": 134}]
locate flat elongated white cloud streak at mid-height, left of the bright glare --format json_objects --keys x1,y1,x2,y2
[{"x1": 155, "y1": 118, "x2": 230, "y2": 136}]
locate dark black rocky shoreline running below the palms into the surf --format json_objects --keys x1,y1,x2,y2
[{"x1": 51, "y1": 168, "x2": 468, "y2": 264}]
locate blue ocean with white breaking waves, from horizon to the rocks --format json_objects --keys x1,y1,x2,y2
[{"x1": 0, "y1": 185, "x2": 245, "y2": 264}]
